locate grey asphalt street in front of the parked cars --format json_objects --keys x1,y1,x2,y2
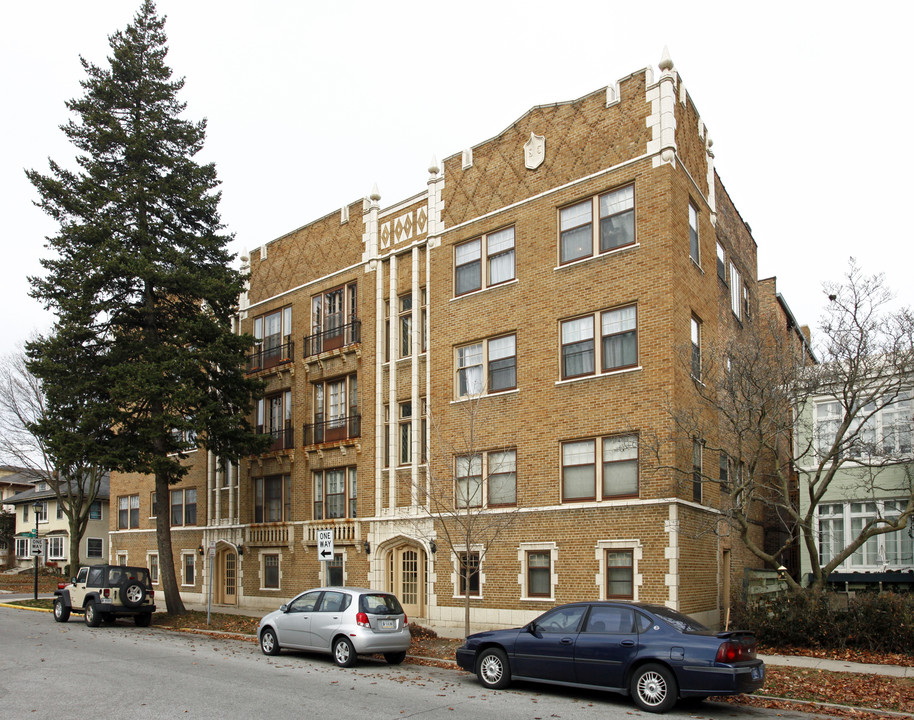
[{"x1": 0, "y1": 607, "x2": 840, "y2": 720}]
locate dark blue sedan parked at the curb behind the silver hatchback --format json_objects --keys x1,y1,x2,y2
[{"x1": 457, "y1": 602, "x2": 765, "y2": 712}]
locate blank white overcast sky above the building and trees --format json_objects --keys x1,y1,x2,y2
[{"x1": 0, "y1": 0, "x2": 914, "y2": 360}]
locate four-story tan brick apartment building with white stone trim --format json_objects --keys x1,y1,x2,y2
[{"x1": 111, "y1": 55, "x2": 800, "y2": 628}]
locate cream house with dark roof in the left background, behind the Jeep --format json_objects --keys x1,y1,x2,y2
[{"x1": 6, "y1": 475, "x2": 109, "y2": 572}]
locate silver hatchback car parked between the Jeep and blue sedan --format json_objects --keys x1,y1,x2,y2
[{"x1": 257, "y1": 587, "x2": 411, "y2": 667}]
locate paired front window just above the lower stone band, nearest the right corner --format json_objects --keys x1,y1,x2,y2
[{"x1": 562, "y1": 435, "x2": 638, "y2": 501}]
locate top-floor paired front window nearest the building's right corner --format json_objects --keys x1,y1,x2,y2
[{"x1": 559, "y1": 185, "x2": 635, "y2": 265}]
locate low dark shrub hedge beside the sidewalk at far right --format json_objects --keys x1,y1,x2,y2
[{"x1": 730, "y1": 591, "x2": 914, "y2": 653}]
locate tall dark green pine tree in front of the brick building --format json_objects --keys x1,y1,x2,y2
[{"x1": 27, "y1": 0, "x2": 263, "y2": 614}]
